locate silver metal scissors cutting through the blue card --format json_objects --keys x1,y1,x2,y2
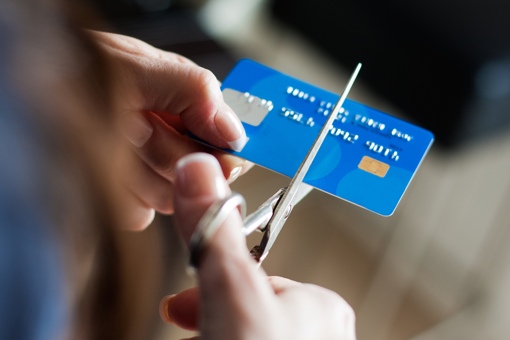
[{"x1": 190, "y1": 64, "x2": 361, "y2": 268}]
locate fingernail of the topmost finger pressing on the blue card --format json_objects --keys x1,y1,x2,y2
[{"x1": 214, "y1": 108, "x2": 248, "y2": 151}]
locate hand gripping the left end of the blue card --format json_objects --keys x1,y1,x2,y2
[{"x1": 90, "y1": 31, "x2": 251, "y2": 229}]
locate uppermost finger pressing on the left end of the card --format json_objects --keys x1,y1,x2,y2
[{"x1": 91, "y1": 32, "x2": 247, "y2": 151}]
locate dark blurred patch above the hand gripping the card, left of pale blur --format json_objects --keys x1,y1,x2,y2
[{"x1": 92, "y1": 0, "x2": 235, "y2": 80}]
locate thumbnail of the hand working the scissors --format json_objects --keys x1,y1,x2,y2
[{"x1": 176, "y1": 153, "x2": 227, "y2": 199}]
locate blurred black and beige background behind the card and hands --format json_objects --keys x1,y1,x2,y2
[{"x1": 93, "y1": 0, "x2": 510, "y2": 340}]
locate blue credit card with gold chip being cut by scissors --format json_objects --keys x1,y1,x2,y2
[{"x1": 207, "y1": 59, "x2": 434, "y2": 216}]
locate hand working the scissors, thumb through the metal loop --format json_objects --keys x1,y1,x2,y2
[{"x1": 161, "y1": 154, "x2": 355, "y2": 340}]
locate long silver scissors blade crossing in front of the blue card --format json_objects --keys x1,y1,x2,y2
[{"x1": 254, "y1": 63, "x2": 361, "y2": 262}]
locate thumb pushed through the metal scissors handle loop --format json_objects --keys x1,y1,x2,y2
[{"x1": 174, "y1": 154, "x2": 274, "y2": 339}]
